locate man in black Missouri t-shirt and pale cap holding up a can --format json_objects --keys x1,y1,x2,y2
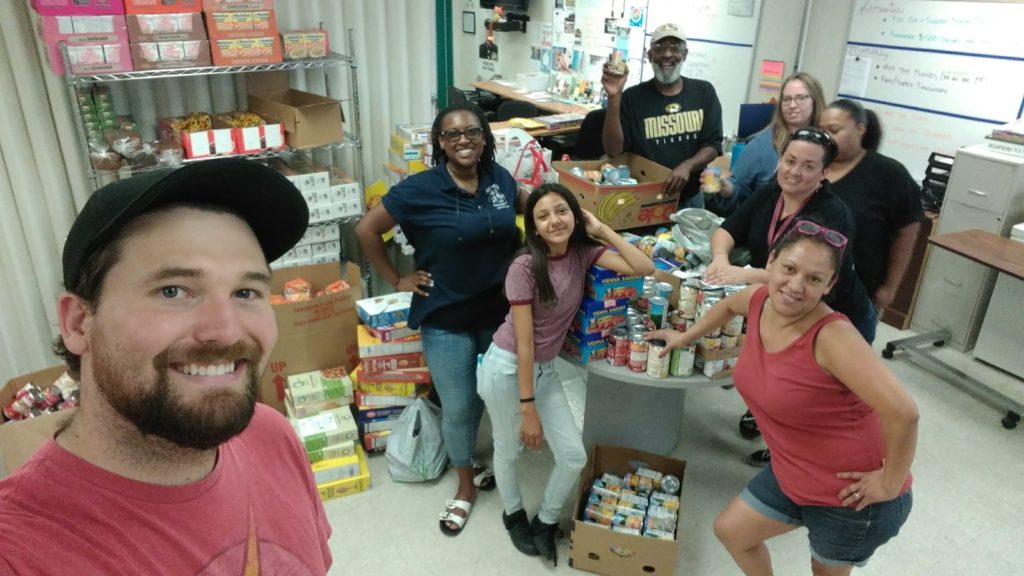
[{"x1": 601, "y1": 24, "x2": 722, "y2": 208}]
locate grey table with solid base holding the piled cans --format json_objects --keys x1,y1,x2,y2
[{"x1": 560, "y1": 354, "x2": 732, "y2": 455}]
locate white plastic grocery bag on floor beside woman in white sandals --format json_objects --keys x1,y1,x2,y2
[{"x1": 386, "y1": 398, "x2": 447, "y2": 482}]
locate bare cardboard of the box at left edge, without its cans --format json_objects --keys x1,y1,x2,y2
[{"x1": 0, "y1": 365, "x2": 76, "y2": 478}]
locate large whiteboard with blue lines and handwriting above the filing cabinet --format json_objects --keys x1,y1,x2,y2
[{"x1": 839, "y1": 0, "x2": 1024, "y2": 179}]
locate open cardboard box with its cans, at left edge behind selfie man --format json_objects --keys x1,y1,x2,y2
[{"x1": 0, "y1": 365, "x2": 78, "y2": 478}]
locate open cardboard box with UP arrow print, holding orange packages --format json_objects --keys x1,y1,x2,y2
[{"x1": 260, "y1": 262, "x2": 361, "y2": 414}]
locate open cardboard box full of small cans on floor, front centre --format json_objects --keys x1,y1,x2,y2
[{"x1": 569, "y1": 445, "x2": 686, "y2": 576}]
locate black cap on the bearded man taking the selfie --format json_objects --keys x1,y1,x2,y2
[{"x1": 62, "y1": 158, "x2": 309, "y2": 290}]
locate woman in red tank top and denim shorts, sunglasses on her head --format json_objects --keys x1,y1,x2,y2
[{"x1": 646, "y1": 219, "x2": 918, "y2": 576}]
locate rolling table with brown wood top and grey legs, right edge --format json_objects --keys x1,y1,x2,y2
[{"x1": 882, "y1": 230, "x2": 1024, "y2": 429}]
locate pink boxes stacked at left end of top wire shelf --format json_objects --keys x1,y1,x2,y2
[{"x1": 32, "y1": 0, "x2": 132, "y2": 76}]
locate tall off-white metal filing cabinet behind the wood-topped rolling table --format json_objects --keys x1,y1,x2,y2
[{"x1": 910, "y1": 145, "x2": 1024, "y2": 351}]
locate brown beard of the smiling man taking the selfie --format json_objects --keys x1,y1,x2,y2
[{"x1": 92, "y1": 336, "x2": 263, "y2": 450}]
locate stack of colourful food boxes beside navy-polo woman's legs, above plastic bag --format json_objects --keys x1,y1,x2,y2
[{"x1": 355, "y1": 292, "x2": 430, "y2": 452}]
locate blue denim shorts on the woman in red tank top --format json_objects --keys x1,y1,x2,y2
[{"x1": 739, "y1": 465, "x2": 913, "y2": 566}]
